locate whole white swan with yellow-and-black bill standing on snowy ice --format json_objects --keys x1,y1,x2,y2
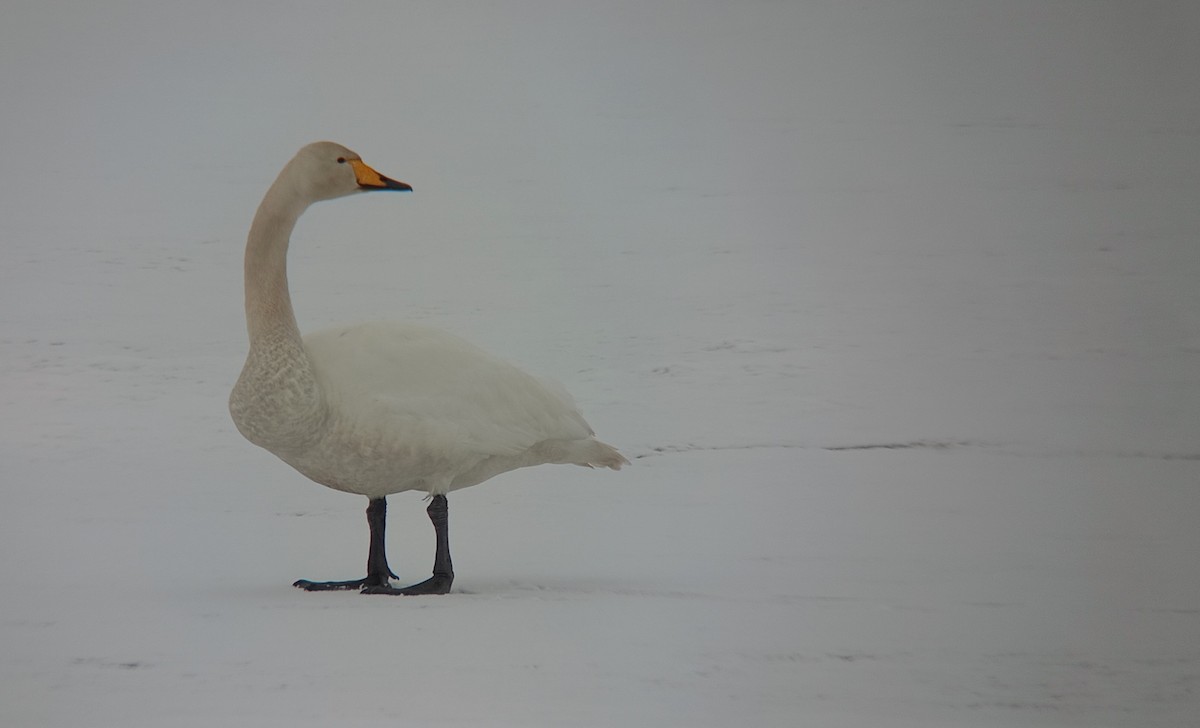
[{"x1": 229, "y1": 142, "x2": 629, "y2": 595}]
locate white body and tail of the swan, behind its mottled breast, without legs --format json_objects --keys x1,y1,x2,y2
[{"x1": 296, "y1": 324, "x2": 620, "y2": 498}]
